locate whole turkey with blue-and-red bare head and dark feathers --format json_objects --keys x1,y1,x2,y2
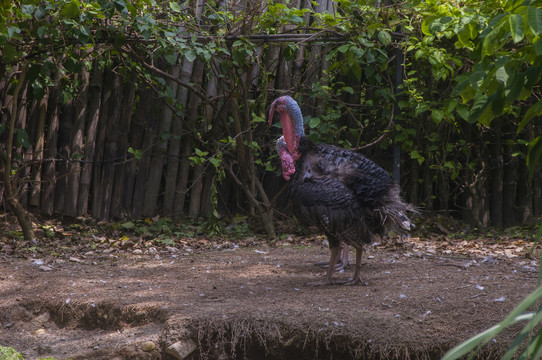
[{"x1": 269, "y1": 96, "x2": 416, "y2": 285}]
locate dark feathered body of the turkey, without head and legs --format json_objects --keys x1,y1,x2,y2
[{"x1": 290, "y1": 137, "x2": 410, "y2": 248}]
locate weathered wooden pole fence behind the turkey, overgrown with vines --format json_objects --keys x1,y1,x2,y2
[{"x1": 0, "y1": 0, "x2": 542, "y2": 235}]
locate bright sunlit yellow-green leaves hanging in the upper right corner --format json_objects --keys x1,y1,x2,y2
[{"x1": 409, "y1": 0, "x2": 542, "y2": 174}]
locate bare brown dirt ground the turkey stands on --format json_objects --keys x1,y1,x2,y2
[{"x1": 0, "y1": 222, "x2": 538, "y2": 359}]
